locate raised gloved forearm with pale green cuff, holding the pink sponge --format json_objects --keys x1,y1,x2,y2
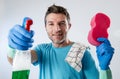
[{"x1": 96, "y1": 38, "x2": 114, "y2": 79}]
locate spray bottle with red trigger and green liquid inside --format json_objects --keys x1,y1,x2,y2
[{"x1": 12, "y1": 17, "x2": 33, "y2": 79}]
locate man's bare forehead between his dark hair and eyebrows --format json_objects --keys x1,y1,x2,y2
[{"x1": 46, "y1": 13, "x2": 67, "y2": 22}]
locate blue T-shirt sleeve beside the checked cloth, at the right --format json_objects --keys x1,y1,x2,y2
[{"x1": 82, "y1": 49, "x2": 99, "y2": 79}]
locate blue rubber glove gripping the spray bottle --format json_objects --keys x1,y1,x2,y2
[{"x1": 8, "y1": 25, "x2": 34, "y2": 50}]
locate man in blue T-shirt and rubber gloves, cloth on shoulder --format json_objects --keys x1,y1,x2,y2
[{"x1": 8, "y1": 5, "x2": 114, "y2": 79}]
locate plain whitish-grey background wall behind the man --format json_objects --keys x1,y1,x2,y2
[{"x1": 0, "y1": 0, "x2": 120, "y2": 79}]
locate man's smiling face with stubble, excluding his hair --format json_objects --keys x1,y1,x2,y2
[{"x1": 45, "y1": 13, "x2": 71, "y2": 44}]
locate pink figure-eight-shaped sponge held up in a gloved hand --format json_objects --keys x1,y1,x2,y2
[{"x1": 88, "y1": 13, "x2": 110, "y2": 46}]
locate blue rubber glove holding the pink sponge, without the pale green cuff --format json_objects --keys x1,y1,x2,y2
[{"x1": 96, "y1": 38, "x2": 114, "y2": 70}]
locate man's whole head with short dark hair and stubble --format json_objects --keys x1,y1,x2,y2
[{"x1": 44, "y1": 5, "x2": 71, "y2": 44}]
